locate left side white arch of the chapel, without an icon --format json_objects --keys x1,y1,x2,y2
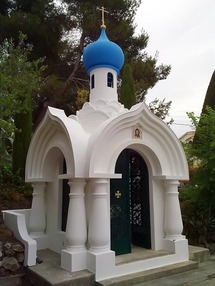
[{"x1": 26, "y1": 107, "x2": 87, "y2": 181}]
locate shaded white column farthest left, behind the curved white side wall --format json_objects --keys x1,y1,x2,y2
[{"x1": 28, "y1": 182, "x2": 46, "y2": 236}]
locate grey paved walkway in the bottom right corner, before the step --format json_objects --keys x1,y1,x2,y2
[{"x1": 134, "y1": 255, "x2": 215, "y2": 286}]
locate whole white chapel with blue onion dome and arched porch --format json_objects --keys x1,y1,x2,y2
[{"x1": 4, "y1": 14, "x2": 189, "y2": 281}]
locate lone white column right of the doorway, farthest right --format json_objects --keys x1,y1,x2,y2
[{"x1": 164, "y1": 180, "x2": 183, "y2": 240}]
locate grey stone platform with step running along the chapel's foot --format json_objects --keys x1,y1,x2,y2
[{"x1": 23, "y1": 246, "x2": 210, "y2": 286}]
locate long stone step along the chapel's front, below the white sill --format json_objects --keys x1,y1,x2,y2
[{"x1": 95, "y1": 260, "x2": 198, "y2": 286}]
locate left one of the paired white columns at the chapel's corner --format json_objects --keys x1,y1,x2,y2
[{"x1": 65, "y1": 179, "x2": 87, "y2": 251}]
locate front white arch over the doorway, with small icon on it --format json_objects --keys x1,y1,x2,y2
[{"x1": 88, "y1": 103, "x2": 189, "y2": 179}]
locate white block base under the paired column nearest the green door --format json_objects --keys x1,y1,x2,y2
[{"x1": 87, "y1": 250, "x2": 115, "y2": 280}]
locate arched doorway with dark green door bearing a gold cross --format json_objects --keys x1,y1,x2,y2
[{"x1": 110, "y1": 149, "x2": 151, "y2": 255}]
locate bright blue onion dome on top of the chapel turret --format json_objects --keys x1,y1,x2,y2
[{"x1": 83, "y1": 27, "x2": 124, "y2": 74}]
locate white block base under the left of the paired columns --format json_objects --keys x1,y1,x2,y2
[{"x1": 61, "y1": 249, "x2": 87, "y2": 272}]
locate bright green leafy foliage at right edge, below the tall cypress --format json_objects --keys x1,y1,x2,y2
[{"x1": 188, "y1": 106, "x2": 215, "y2": 215}]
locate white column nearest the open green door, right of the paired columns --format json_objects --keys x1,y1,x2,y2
[{"x1": 88, "y1": 179, "x2": 110, "y2": 252}]
